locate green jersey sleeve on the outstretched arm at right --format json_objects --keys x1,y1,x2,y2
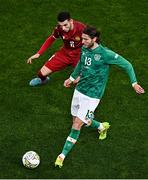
[{"x1": 105, "y1": 51, "x2": 137, "y2": 84}]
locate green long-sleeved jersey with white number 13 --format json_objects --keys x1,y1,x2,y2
[{"x1": 70, "y1": 44, "x2": 137, "y2": 99}]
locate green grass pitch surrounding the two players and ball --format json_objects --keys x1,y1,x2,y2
[{"x1": 0, "y1": 0, "x2": 148, "y2": 179}]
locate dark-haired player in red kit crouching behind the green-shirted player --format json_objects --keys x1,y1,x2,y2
[{"x1": 27, "y1": 12, "x2": 85, "y2": 86}]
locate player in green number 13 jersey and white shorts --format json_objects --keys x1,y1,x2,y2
[{"x1": 55, "y1": 26, "x2": 144, "y2": 167}]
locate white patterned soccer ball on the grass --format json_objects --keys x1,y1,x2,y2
[{"x1": 22, "y1": 151, "x2": 40, "y2": 169}]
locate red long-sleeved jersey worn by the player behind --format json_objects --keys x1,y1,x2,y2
[{"x1": 37, "y1": 20, "x2": 85, "y2": 54}]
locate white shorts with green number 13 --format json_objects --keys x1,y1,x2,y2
[{"x1": 71, "y1": 89, "x2": 100, "y2": 124}]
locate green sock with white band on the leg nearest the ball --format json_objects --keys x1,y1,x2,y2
[{"x1": 62, "y1": 129, "x2": 80, "y2": 156}]
